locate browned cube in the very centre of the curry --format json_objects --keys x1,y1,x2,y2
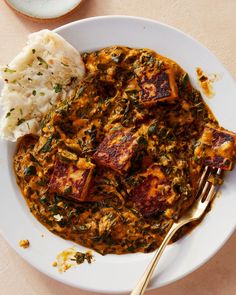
[{"x1": 93, "y1": 130, "x2": 138, "y2": 174}]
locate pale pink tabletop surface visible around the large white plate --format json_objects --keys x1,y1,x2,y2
[{"x1": 0, "y1": 0, "x2": 236, "y2": 295}]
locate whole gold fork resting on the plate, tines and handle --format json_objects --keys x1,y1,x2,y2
[{"x1": 130, "y1": 166, "x2": 221, "y2": 295}]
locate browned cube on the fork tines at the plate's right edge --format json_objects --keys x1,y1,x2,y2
[{"x1": 194, "y1": 126, "x2": 236, "y2": 170}]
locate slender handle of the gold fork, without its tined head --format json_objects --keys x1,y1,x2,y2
[{"x1": 130, "y1": 222, "x2": 187, "y2": 295}]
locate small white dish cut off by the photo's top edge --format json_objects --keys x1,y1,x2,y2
[{"x1": 5, "y1": 0, "x2": 82, "y2": 19}]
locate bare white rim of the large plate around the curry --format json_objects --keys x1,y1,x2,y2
[{"x1": 0, "y1": 16, "x2": 236, "y2": 293}]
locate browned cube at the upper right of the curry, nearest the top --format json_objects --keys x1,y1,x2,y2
[{"x1": 139, "y1": 69, "x2": 178, "y2": 107}]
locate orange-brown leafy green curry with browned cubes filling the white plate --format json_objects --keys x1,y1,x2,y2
[{"x1": 3, "y1": 46, "x2": 235, "y2": 254}]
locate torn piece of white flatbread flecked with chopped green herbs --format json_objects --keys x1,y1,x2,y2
[{"x1": 0, "y1": 30, "x2": 85, "y2": 141}]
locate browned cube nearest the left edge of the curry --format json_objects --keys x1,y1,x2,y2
[{"x1": 49, "y1": 158, "x2": 95, "y2": 201}]
